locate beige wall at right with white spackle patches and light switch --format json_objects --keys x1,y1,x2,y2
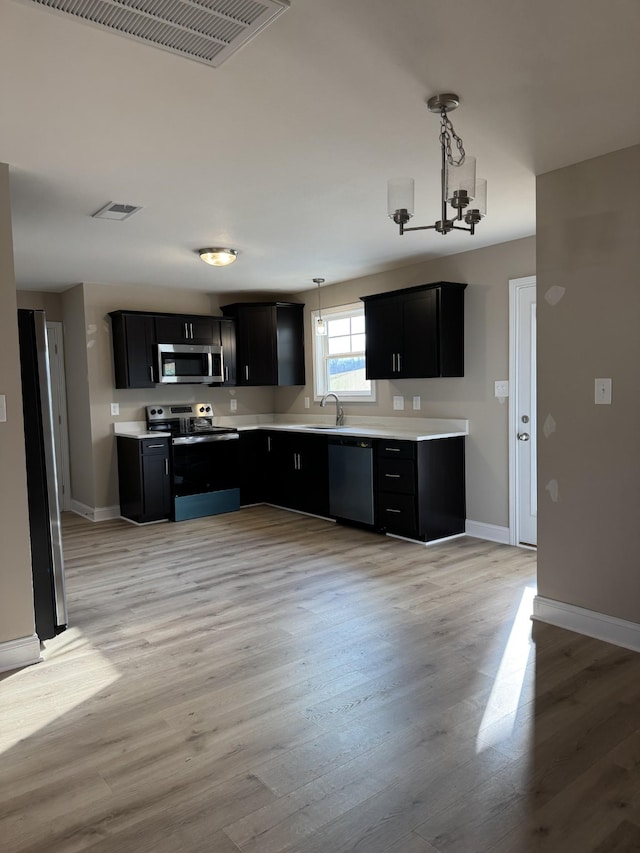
[{"x1": 537, "y1": 146, "x2": 640, "y2": 623}]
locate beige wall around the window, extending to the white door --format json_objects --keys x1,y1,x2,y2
[{"x1": 276, "y1": 235, "x2": 535, "y2": 527}]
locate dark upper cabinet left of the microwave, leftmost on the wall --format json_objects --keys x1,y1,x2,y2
[{"x1": 109, "y1": 311, "x2": 156, "y2": 388}]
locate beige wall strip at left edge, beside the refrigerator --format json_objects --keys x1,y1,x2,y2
[{"x1": 0, "y1": 163, "x2": 34, "y2": 643}]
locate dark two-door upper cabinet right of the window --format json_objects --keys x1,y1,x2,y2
[{"x1": 361, "y1": 281, "x2": 467, "y2": 379}]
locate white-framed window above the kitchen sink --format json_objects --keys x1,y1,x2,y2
[{"x1": 311, "y1": 303, "x2": 376, "y2": 402}]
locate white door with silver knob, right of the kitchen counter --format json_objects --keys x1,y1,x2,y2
[{"x1": 509, "y1": 277, "x2": 538, "y2": 546}]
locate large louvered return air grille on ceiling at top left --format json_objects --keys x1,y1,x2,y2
[{"x1": 26, "y1": 0, "x2": 289, "y2": 67}]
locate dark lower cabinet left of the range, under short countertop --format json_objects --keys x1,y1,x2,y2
[{"x1": 117, "y1": 435, "x2": 171, "y2": 524}]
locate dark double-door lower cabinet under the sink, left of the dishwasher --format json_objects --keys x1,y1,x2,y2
[{"x1": 265, "y1": 430, "x2": 329, "y2": 516}]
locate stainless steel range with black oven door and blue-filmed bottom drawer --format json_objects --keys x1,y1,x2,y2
[{"x1": 146, "y1": 403, "x2": 240, "y2": 521}]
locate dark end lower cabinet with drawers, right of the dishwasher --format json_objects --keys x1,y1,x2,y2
[{"x1": 375, "y1": 437, "x2": 466, "y2": 542}]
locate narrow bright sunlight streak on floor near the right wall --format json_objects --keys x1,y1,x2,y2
[{"x1": 476, "y1": 586, "x2": 536, "y2": 753}]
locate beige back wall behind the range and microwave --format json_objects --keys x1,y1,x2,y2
[{"x1": 70, "y1": 284, "x2": 274, "y2": 510}]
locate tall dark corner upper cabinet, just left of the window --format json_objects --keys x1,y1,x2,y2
[{"x1": 222, "y1": 302, "x2": 305, "y2": 385}]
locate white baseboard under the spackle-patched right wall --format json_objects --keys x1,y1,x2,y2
[{"x1": 533, "y1": 595, "x2": 640, "y2": 652}]
